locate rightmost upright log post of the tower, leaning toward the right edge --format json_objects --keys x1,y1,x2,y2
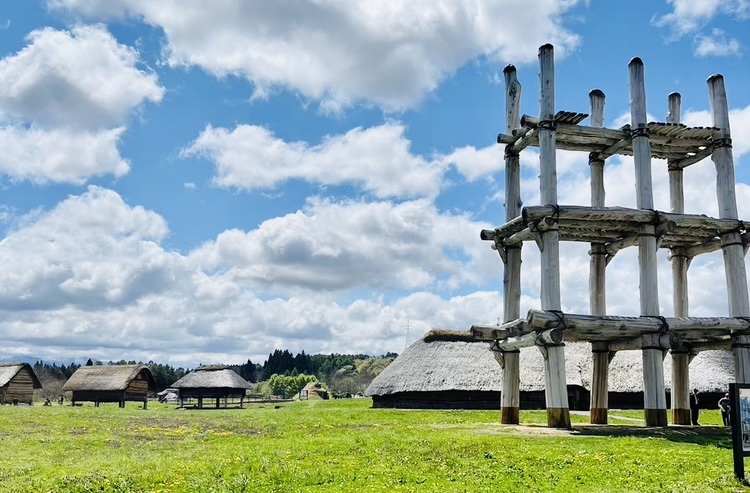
[{"x1": 708, "y1": 75, "x2": 750, "y2": 383}]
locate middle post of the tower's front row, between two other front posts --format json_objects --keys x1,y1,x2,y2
[{"x1": 628, "y1": 58, "x2": 667, "y2": 426}]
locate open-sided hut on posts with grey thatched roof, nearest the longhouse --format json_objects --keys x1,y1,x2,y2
[{"x1": 170, "y1": 365, "x2": 252, "y2": 409}]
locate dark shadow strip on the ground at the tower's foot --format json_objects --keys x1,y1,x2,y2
[{"x1": 570, "y1": 425, "x2": 732, "y2": 450}]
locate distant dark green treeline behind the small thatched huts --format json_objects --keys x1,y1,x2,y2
[{"x1": 34, "y1": 349, "x2": 398, "y2": 398}]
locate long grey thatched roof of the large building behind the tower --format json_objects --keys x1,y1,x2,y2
[{"x1": 365, "y1": 337, "x2": 734, "y2": 396}]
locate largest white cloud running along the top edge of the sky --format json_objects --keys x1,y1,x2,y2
[{"x1": 49, "y1": 0, "x2": 580, "y2": 110}]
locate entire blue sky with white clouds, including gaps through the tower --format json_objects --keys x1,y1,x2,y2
[{"x1": 0, "y1": 0, "x2": 750, "y2": 365}]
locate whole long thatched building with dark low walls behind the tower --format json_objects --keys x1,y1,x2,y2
[{"x1": 365, "y1": 334, "x2": 734, "y2": 410}]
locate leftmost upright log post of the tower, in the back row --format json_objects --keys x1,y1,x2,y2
[{"x1": 496, "y1": 65, "x2": 523, "y2": 425}]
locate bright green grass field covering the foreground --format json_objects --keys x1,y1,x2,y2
[{"x1": 0, "y1": 399, "x2": 747, "y2": 493}]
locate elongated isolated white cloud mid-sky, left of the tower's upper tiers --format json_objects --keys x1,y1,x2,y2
[{"x1": 183, "y1": 123, "x2": 443, "y2": 198}]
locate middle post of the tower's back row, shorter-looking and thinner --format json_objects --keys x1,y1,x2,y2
[{"x1": 589, "y1": 89, "x2": 610, "y2": 425}]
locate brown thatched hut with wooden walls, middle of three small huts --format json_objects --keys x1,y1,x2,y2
[{"x1": 62, "y1": 365, "x2": 156, "y2": 409}]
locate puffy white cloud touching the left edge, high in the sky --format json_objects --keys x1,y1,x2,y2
[{"x1": 0, "y1": 26, "x2": 164, "y2": 184}]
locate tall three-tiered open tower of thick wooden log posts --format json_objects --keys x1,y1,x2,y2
[{"x1": 472, "y1": 45, "x2": 750, "y2": 428}]
